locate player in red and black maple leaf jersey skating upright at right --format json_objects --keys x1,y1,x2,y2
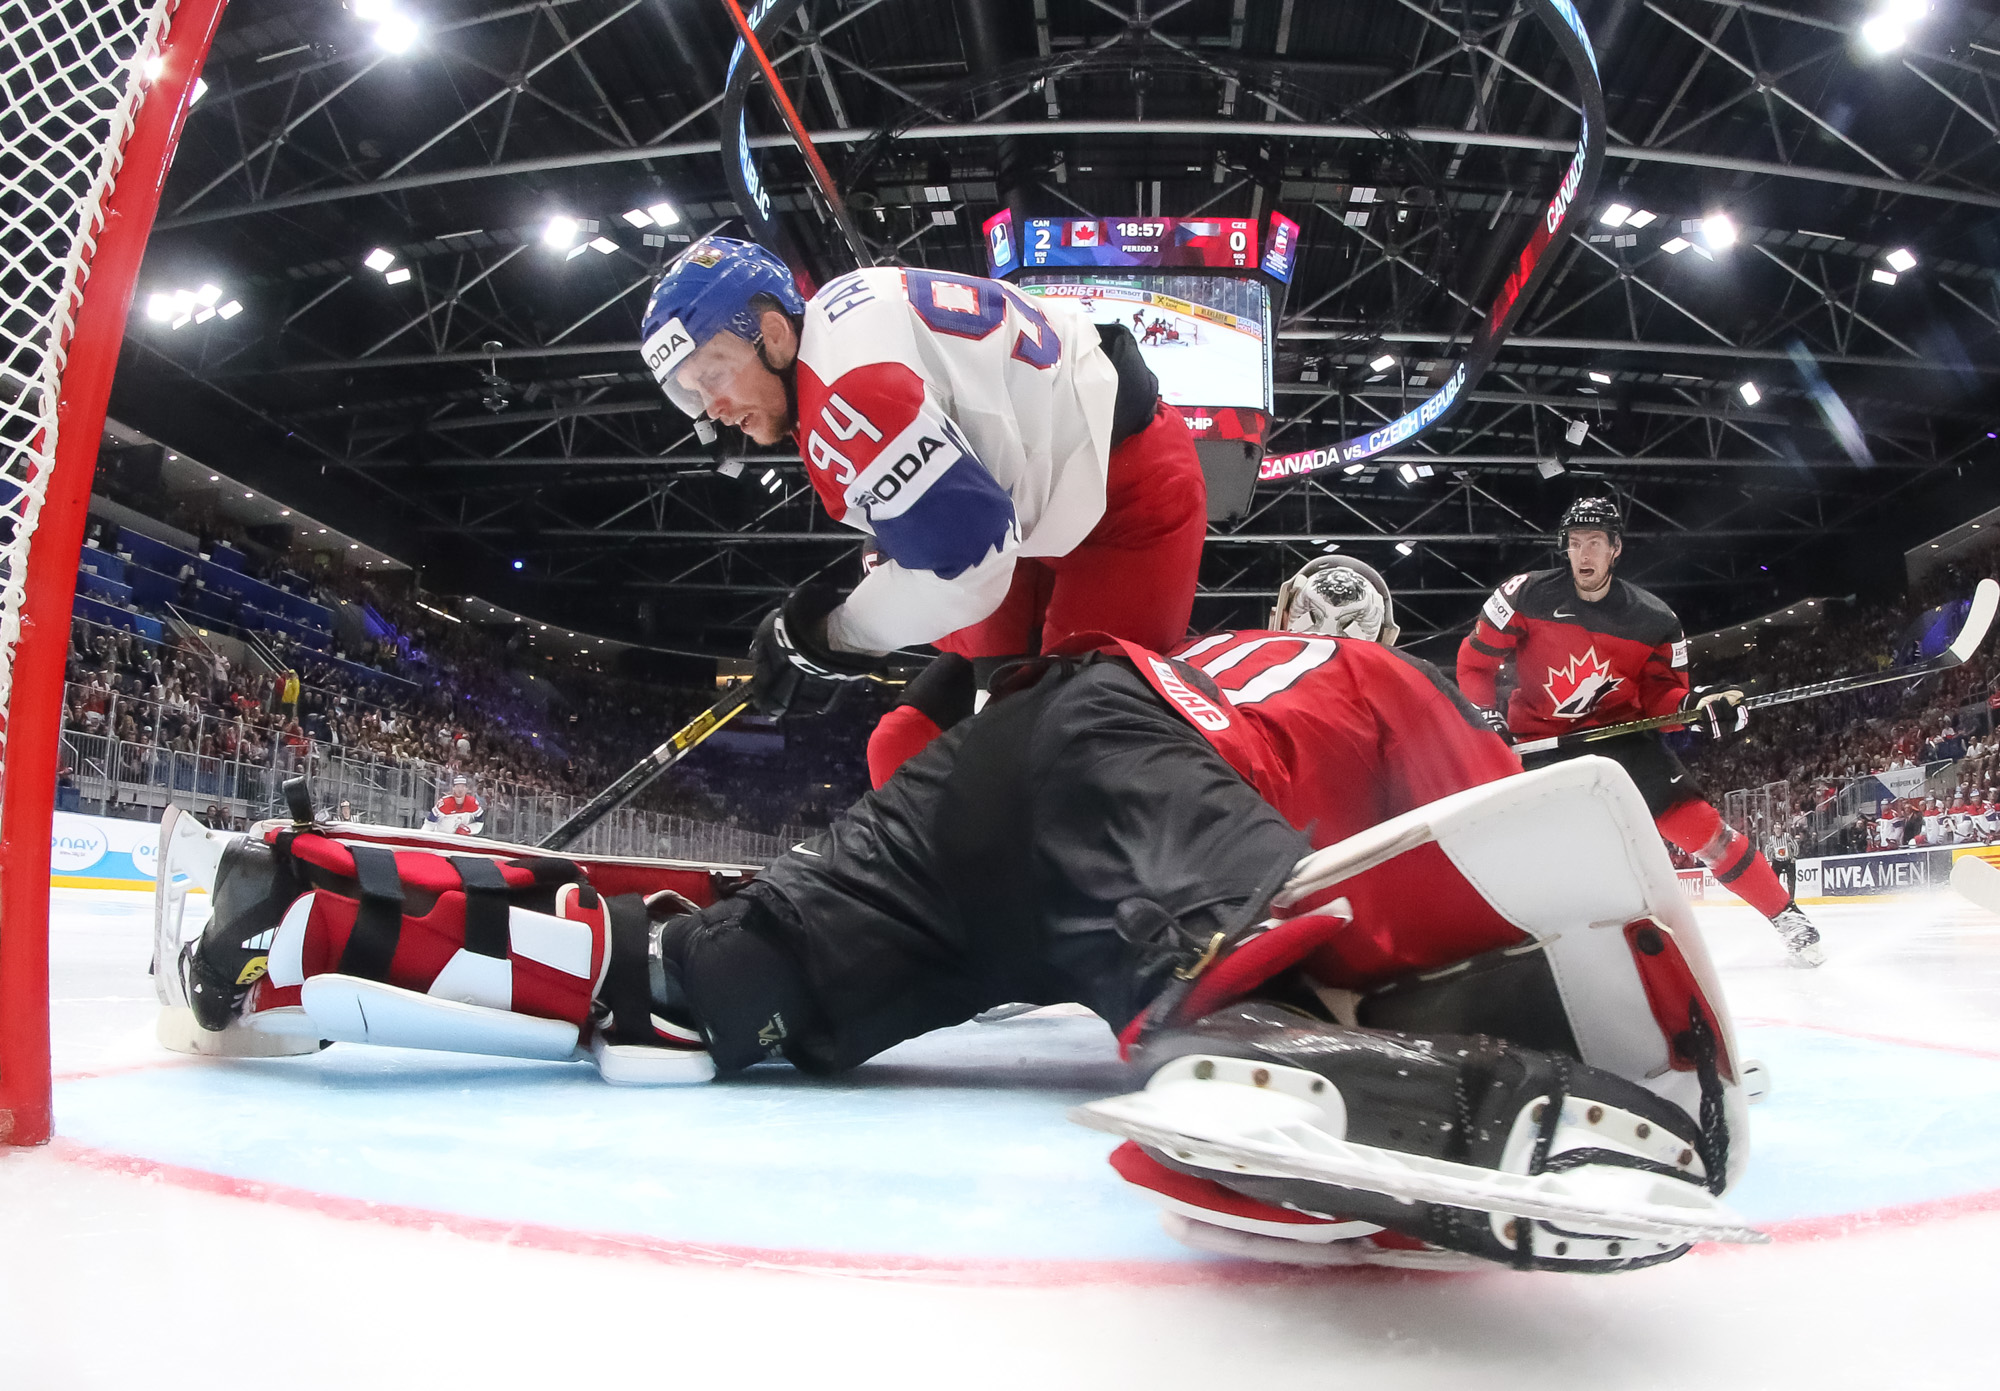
[{"x1": 1458, "y1": 498, "x2": 1826, "y2": 967}]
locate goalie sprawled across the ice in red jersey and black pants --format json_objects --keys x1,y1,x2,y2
[{"x1": 160, "y1": 632, "x2": 1754, "y2": 1271}]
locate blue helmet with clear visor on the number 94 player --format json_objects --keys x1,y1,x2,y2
[{"x1": 640, "y1": 236, "x2": 806, "y2": 420}]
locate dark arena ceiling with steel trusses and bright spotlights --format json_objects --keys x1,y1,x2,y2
[{"x1": 112, "y1": 0, "x2": 2000, "y2": 658}]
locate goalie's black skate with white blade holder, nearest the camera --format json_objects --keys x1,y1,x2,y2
[{"x1": 1078, "y1": 1003, "x2": 1740, "y2": 1271}]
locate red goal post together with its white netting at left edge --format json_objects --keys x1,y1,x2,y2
[{"x1": 0, "y1": 0, "x2": 224, "y2": 1145}]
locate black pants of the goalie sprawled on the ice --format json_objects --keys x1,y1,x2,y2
[{"x1": 662, "y1": 658, "x2": 1308, "y2": 1071}]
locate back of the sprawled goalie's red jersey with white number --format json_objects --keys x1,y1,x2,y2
[{"x1": 1118, "y1": 632, "x2": 1520, "y2": 847}]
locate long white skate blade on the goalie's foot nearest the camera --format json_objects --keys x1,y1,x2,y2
[{"x1": 1070, "y1": 1059, "x2": 1770, "y2": 1245}]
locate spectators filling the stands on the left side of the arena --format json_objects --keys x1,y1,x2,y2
[{"x1": 64, "y1": 493, "x2": 878, "y2": 829}]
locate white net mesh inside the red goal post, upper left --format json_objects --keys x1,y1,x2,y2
[{"x1": 0, "y1": 0, "x2": 176, "y2": 817}]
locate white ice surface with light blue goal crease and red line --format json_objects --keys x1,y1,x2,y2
[{"x1": 0, "y1": 889, "x2": 2000, "y2": 1391}]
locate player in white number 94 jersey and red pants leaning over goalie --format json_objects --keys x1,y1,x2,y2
[{"x1": 644, "y1": 238, "x2": 1208, "y2": 707}]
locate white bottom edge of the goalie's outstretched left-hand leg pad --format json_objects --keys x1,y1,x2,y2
[{"x1": 300, "y1": 973, "x2": 578, "y2": 1061}]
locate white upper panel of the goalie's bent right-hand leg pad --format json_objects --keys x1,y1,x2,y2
[{"x1": 1278, "y1": 757, "x2": 1748, "y2": 1181}]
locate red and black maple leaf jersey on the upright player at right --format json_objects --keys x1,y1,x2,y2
[{"x1": 1458, "y1": 568, "x2": 1688, "y2": 737}]
